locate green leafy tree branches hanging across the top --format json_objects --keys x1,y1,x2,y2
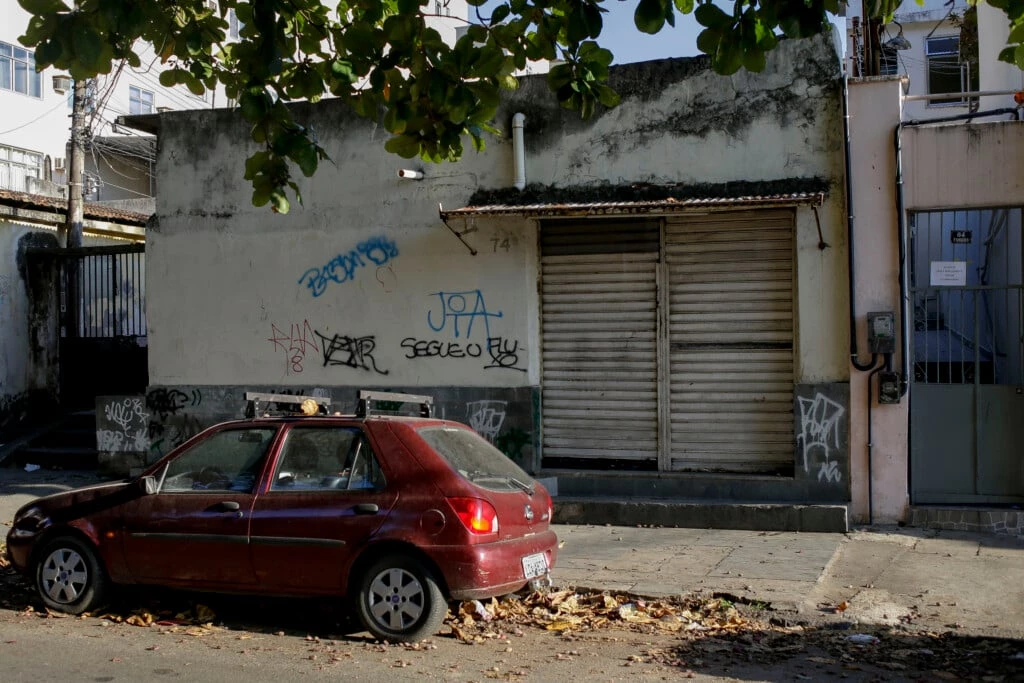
[{"x1": 18, "y1": 0, "x2": 1024, "y2": 213}]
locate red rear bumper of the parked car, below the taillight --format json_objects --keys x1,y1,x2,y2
[{"x1": 424, "y1": 530, "x2": 558, "y2": 600}]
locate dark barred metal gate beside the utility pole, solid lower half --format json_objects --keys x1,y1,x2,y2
[{"x1": 54, "y1": 245, "x2": 148, "y2": 410}]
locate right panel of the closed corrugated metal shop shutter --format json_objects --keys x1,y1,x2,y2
[{"x1": 665, "y1": 210, "x2": 794, "y2": 472}]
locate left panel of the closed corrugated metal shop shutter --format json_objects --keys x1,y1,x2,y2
[{"x1": 541, "y1": 221, "x2": 659, "y2": 469}]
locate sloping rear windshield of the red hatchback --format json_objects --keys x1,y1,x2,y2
[{"x1": 419, "y1": 427, "x2": 535, "y2": 490}]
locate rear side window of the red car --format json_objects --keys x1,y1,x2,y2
[{"x1": 270, "y1": 427, "x2": 384, "y2": 492}]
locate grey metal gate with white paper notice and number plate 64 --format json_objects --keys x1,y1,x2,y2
[{"x1": 909, "y1": 208, "x2": 1024, "y2": 504}]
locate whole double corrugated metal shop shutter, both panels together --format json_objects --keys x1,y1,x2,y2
[{"x1": 541, "y1": 209, "x2": 795, "y2": 472}]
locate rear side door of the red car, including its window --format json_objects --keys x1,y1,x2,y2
[{"x1": 250, "y1": 423, "x2": 397, "y2": 595}]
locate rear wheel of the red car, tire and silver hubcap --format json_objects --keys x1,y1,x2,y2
[{"x1": 355, "y1": 555, "x2": 447, "y2": 643}]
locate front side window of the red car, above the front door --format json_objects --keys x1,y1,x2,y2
[{"x1": 160, "y1": 428, "x2": 276, "y2": 494}]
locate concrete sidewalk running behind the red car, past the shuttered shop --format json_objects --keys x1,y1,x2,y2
[{"x1": 6, "y1": 468, "x2": 1024, "y2": 638}]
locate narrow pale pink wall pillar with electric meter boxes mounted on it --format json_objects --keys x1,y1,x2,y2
[{"x1": 849, "y1": 78, "x2": 909, "y2": 523}]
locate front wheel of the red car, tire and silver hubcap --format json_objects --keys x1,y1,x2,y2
[{"x1": 35, "y1": 536, "x2": 109, "y2": 614}]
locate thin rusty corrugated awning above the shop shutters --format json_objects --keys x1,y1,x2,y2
[{"x1": 440, "y1": 191, "x2": 826, "y2": 220}]
